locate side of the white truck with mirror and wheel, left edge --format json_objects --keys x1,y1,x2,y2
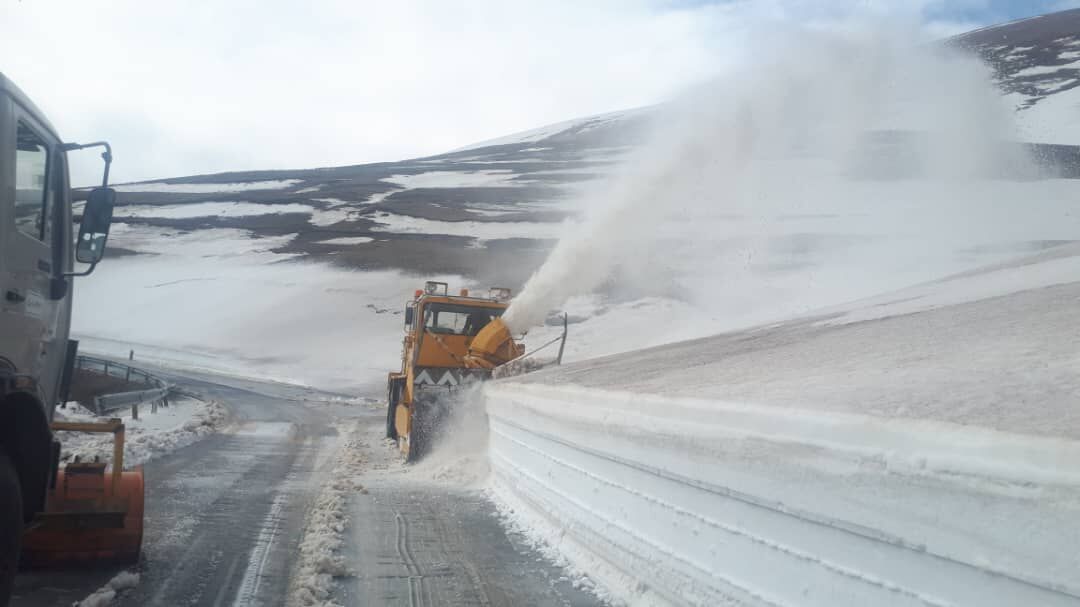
[{"x1": 0, "y1": 75, "x2": 116, "y2": 605}]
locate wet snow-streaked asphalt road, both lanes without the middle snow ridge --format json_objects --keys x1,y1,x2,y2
[{"x1": 12, "y1": 362, "x2": 597, "y2": 607}]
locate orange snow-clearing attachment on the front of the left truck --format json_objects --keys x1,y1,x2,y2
[{"x1": 22, "y1": 419, "x2": 144, "y2": 567}]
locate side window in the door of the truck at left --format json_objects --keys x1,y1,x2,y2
[{"x1": 15, "y1": 121, "x2": 49, "y2": 240}]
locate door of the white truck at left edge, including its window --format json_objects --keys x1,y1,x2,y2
[{"x1": 0, "y1": 102, "x2": 64, "y2": 399}]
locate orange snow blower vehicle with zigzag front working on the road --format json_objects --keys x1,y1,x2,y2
[{"x1": 387, "y1": 281, "x2": 525, "y2": 461}]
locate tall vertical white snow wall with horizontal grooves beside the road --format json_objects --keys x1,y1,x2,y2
[{"x1": 485, "y1": 382, "x2": 1080, "y2": 606}]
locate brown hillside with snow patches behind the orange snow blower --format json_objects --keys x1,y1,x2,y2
[{"x1": 75, "y1": 12, "x2": 1080, "y2": 394}]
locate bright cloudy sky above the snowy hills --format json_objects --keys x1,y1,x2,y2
[{"x1": 0, "y1": 0, "x2": 1075, "y2": 184}]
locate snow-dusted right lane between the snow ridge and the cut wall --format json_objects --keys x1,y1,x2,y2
[{"x1": 334, "y1": 419, "x2": 600, "y2": 607}]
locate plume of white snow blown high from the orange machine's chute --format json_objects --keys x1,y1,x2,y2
[{"x1": 504, "y1": 23, "x2": 1029, "y2": 332}]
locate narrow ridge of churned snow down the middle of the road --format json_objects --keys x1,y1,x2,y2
[{"x1": 286, "y1": 424, "x2": 363, "y2": 607}]
